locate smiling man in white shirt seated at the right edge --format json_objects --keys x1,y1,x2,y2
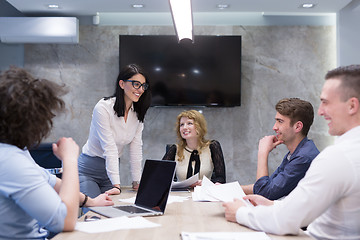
[{"x1": 223, "y1": 65, "x2": 360, "y2": 239}]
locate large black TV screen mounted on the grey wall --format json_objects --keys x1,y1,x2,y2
[{"x1": 119, "y1": 35, "x2": 241, "y2": 107}]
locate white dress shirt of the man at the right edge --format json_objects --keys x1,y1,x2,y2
[{"x1": 236, "y1": 126, "x2": 360, "y2": 239}]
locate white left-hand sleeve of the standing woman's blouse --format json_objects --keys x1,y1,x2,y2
[{"x1": 92, "y1": 103, "x2": 120, "y2": 184}]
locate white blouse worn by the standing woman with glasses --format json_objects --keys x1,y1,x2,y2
[{"x1": 82, "y1": 98, "x2": 144, "y2": 184}]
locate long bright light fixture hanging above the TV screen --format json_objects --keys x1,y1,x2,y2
[{"x1": 169, "y1": 0, "x2": 193, "y2": 42}]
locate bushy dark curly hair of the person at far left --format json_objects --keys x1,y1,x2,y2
[{"x1": 0, "y1": 67, "x2": 67, "y2": 149}]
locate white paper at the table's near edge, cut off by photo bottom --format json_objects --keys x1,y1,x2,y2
[{"x1": 181, "y1": 232, "x2": 271, "y2": 240}]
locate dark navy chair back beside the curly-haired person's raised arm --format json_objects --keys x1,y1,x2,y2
[{"x1": 29, "y1": 143, "x2": 62, "y2": 177}]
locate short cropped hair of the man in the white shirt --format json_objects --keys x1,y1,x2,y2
[{"x1": 325, "y1": 65, "x2": 360, "y2": 101}]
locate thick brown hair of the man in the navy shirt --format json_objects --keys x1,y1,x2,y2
[{"x1": 275, "y1": 98, "x2": 314, "y2": 136}]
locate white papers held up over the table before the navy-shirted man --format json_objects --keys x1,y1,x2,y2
[{"x1": 192, "y1": 176, "x2": 253, "y2": 207}]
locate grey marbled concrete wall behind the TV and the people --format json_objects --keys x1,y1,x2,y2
[{"x1": 24, "y1": 25, "x2": 336, "y2": 184}]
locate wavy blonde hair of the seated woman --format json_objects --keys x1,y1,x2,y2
[{"x1": 175, "y1": 110, "x2": 210, "y2": 161}]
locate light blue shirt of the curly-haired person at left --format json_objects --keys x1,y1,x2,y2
[{"x1": 0, "y1": 143, "x2": 67, "y2": 239}]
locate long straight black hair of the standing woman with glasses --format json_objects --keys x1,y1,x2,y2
[{"x1": 104, "y1": 64, "x2": 151, "y2": 122}]
